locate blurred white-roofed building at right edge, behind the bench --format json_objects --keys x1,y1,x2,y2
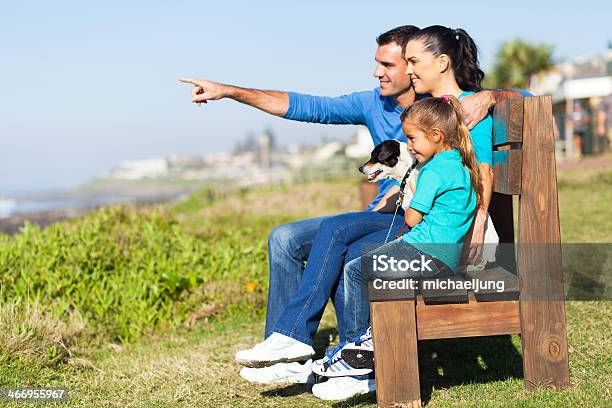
[{"x1": 530, "y1": 49, "x2": 612, "y2": 158}]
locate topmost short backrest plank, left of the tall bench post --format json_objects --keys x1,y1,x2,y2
[{"x1": 493, "y1": 98, "x2": 523, "y2": 146}]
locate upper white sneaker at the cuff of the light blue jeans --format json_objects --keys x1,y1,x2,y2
[{"x1": 236, "y1": 333, "x2": 314, "y2": 367}]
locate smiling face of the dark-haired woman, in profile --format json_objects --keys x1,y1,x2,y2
[{"x1": 404, "y1": 40, "x2": 442, "y2": 94}]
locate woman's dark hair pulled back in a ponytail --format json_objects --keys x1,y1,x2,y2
[{"x1": 410, "y1": 25, "x2": 484, "y2": 92}]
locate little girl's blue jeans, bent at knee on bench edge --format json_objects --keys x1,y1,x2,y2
[{"x1": 344, "y1": 238, "x2": 446, "y2": 338}]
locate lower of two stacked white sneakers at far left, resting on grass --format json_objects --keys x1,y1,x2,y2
[{"x1": 240, "y1": 360, "x2": 314, "y2": 384}]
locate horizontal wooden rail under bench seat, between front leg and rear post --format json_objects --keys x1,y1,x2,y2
[{"x1": 416, "y1": 298, "x2": 521, "y2": 340}]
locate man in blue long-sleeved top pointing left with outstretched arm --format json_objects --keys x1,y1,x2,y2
[{"x1": 179, "y1": 26, "x2": 516, "y2": 397}]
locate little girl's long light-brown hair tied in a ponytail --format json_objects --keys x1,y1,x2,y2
[{"x1": 401, "y1": 95, "x2": 482, "y2": 206}]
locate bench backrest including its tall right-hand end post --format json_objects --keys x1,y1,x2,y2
[{"x1": 489, "y1": 96, "x2": 569, "y2": 388}]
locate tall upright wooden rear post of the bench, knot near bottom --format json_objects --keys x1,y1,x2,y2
[{"x1": 517, "y1": 96, "x2": 569, "y2": 389}]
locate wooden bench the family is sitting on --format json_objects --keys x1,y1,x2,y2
[{"x1": 370, "y1": 96, "x2": 569, "y2": 407}]
